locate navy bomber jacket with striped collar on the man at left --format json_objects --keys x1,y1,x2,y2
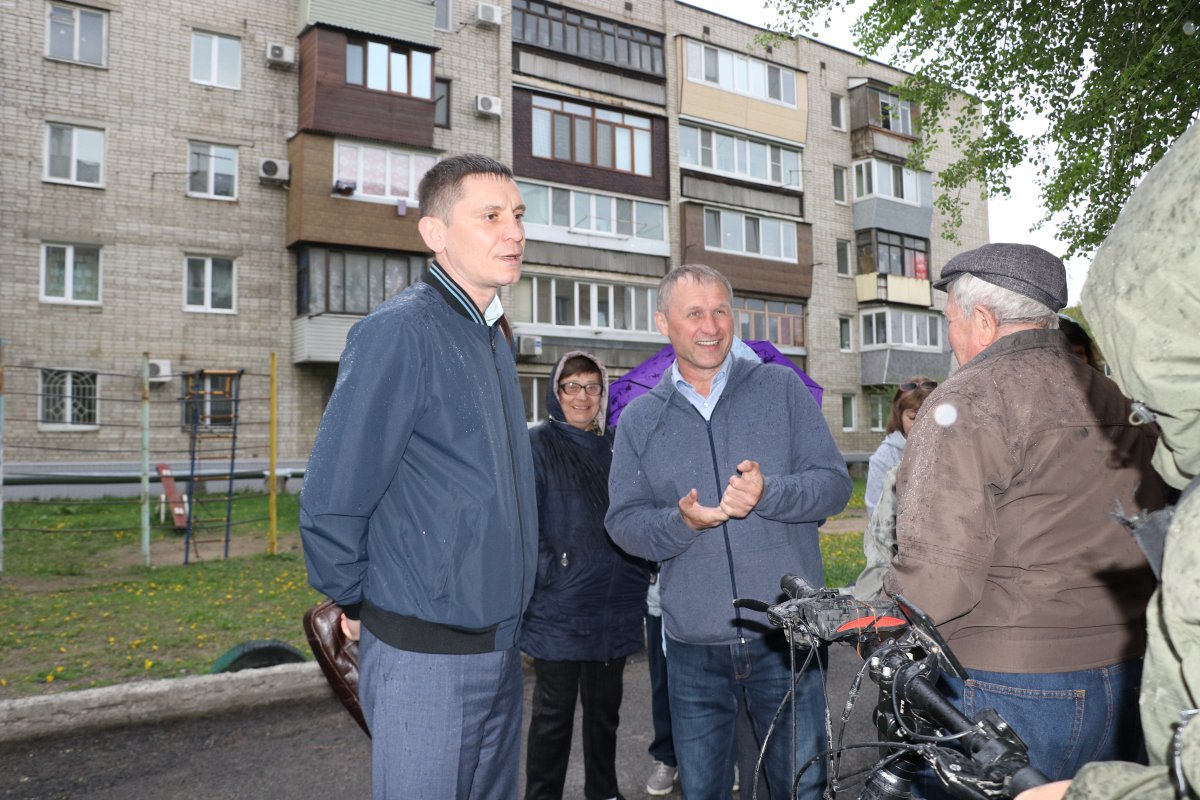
[{"x1": 300, "y1": 267, "x2": 538, "y2": 654}]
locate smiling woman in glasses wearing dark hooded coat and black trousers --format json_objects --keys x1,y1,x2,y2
[{"x1": 521, "y1": 351, "x2": 649, "y2": 800}]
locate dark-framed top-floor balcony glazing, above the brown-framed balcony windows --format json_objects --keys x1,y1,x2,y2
[{"x1": 512, "y1": 0, "x2": 666, "y2": 76}]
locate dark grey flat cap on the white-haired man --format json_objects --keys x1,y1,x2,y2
[{"x1": 934, "y1": 245, "x2": 1067, "y2": 311}]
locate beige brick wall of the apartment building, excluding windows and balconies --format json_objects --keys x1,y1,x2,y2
[{"x1": 0, "y1": 0, "x2": 988, "y2": 474}]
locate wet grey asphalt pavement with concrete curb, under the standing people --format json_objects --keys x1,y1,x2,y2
[{"x1": 0, "y1": 646, "x2": 875, "y2": 800}]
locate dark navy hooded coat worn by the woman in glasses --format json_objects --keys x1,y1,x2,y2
[{"x1": 521, "y1": 353, "x2": 650, "y2": 661}]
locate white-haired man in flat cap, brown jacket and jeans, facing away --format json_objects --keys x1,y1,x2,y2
[{"x1": 884, "y1": 245, "x2": 1163, "y2": 778}]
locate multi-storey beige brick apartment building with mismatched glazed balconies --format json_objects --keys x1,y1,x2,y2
[{"x1": 0, "y1": 0, "x2": 988, "y2": 474}]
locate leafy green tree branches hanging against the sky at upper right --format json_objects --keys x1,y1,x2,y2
[{"x1": 768, "y1": 0, "x2": 1200, "y2": 257}]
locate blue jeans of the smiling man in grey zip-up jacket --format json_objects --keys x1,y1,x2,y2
[{"x1": 667, "y1": 633, "x2": 826, "y2": 800}]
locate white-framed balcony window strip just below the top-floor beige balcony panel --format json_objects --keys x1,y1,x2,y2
[{"x1": 679, "y1": 124, "x2": 803, "y2": 190}]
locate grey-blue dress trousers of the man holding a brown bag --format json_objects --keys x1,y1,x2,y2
[{"x1": 359, "y1": 625, "x2": 524, "y2": 800}]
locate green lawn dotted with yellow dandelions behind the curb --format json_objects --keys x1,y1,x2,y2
[{"x1": 0, "y1": 481, "x2": 863, "y2": 699}]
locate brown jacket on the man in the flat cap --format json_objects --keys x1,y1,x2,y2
[{"x1": 884, "y1": 330, "x2": 1163, "y2": 673}]
